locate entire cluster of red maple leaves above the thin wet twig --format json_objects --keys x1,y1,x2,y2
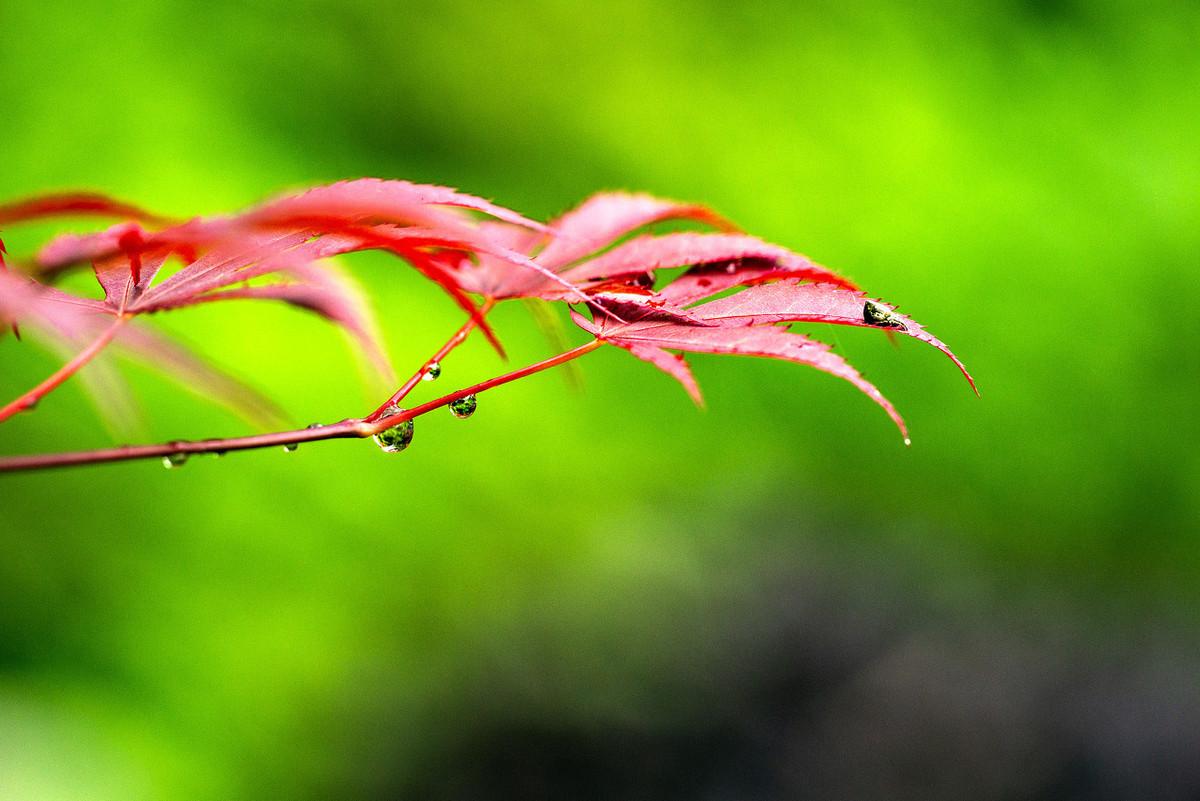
[{"x1": 0, "y1": 179, "x2": 974, "y2": 462}]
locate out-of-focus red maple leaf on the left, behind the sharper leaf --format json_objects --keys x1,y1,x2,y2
[{"x1": 0, "y1": 179, "x2": 566, "y2": 420}]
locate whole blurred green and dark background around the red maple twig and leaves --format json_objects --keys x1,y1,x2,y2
[{"x1": 0, "y1": 0, "x2": 1200, "y2": 801}]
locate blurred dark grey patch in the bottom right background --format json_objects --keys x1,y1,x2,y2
[{"x1": 393, "y1": 544, "x2": 1200, "y2": 801}]
